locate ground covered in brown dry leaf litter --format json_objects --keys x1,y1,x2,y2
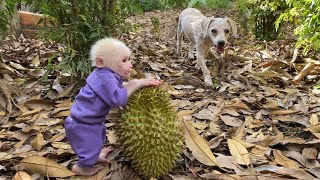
[{"x1": 0, "y1": 8, "x2": 320, "y2": 180}]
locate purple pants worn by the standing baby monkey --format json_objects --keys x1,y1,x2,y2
[{"x1": 65, "y1": 117, "x2": 106, "y2": 168}]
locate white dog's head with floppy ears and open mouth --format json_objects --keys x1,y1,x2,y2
[{"x1": 202, "y1": 17, "x2": 237, "y2": 54}]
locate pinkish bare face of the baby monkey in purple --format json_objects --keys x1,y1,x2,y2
[{"x1": 113, "y1": 51, "x2": 132, "y2": 80}]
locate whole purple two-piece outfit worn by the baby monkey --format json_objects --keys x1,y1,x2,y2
[{"x1": 65, "y1": 68, "x2": 128, "y2": 168}]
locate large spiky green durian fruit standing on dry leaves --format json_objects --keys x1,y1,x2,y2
[{"x1": 116, "y1": 87, "x2": 183, "y2": 178}]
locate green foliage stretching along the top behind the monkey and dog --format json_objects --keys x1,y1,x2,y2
[{"x1": 0, "y1": 0, "x2": 320, "y2": 79}]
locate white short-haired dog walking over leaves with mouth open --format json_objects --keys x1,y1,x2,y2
[{"x1": 177, "y1": 8, "x2": 237, "y2": 85}]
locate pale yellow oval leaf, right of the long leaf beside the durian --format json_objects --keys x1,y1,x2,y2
[{"x1": 228, "y1": 139, "x2": 250, "y2": 165}]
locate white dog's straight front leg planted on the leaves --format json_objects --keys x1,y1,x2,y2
[{"x1": 196, "y1": 44, "x2": 213, "y2": 86}]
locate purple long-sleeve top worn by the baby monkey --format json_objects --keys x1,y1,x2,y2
[{"x1": 71, "y1": 68, "x2": 128, "y2": 124}]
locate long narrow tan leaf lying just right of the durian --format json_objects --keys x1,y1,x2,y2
[{"x1": 183, "y1": 120, "x2": 218, "y2": 166}]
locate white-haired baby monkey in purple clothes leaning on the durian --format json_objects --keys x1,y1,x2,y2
[{"x1": 65, "y1": 38, "x2": 161, "y2": 176}]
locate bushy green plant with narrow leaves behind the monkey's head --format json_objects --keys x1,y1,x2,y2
[{"x1": 26, "y1": 0, "x2": 142, "y2": 79}]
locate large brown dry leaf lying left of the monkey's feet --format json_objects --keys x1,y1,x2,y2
[{"x1": 20, "y1": 156, "x2": 75, "y2": 178}]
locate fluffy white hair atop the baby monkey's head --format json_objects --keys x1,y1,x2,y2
[{"x1": 90, "y1": 37, "x2": 131, "y2": 66}]
